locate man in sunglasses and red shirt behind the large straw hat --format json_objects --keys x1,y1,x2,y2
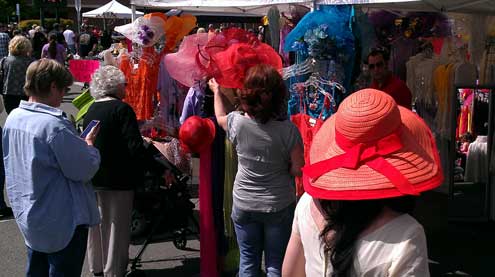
[{"x1": 366, "y1": 49, "x2": 412, "y2": 109}]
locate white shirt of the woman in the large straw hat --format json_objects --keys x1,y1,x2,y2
[{"x1": 292, "y1": 193, "x2": 430, "y2": 277}]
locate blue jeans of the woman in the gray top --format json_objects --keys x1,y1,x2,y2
[{"x1": 232, "y1": 203, "x2": 296, "y2": 277}]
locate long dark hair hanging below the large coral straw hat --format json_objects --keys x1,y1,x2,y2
[{"x1": 319, "y1": 196, "x2": 416, "y2": 277}]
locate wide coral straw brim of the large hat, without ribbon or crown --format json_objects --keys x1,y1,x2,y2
[{"x1": 303, "y1": 107, "x2": 443, "y2": 200}]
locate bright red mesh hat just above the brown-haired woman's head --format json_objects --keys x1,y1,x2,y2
[{"x1": 209, "y1": 42, "x2": 282, "y2": 88}]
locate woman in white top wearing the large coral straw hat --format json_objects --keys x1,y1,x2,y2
[{"x1": 283, "y1": 89, "x2": 443, "y2": 277}]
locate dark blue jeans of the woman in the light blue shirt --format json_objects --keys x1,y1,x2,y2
[{"x1": 26, "y1": 226, "x2": 88, "y2": 277}]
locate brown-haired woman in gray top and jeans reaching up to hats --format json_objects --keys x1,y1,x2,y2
[{"x1": 209, "y1": 64, "x2": 304, "y2": 277}]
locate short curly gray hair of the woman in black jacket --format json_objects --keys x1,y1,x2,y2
[{"x1": 89, "y1": 65, "x2": 125, "y2": 100}]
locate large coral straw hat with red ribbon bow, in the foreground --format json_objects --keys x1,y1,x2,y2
[{"x1": 303, "y1": 89, "x2": 443, "y2": 200}]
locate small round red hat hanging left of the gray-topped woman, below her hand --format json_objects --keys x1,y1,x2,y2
[{"x1": 179, "y1": 115, "x2": 215, "y2": 153}]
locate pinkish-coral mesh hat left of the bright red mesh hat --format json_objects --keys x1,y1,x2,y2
[{"x1": 165, "y1": 33, "x2": 208, "y2": 87}]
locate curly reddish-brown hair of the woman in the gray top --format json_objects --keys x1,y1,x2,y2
[{"x1": 239, "y1": 64, "x2": 287, "y2": 124}]
